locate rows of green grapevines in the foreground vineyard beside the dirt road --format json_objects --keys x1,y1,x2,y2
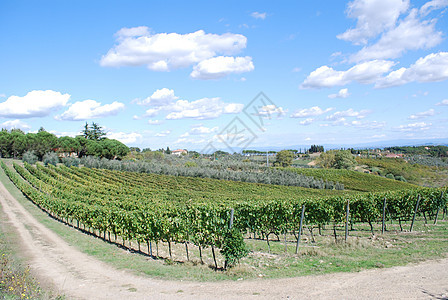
[{"x1": 1, "y1": 161, "x2": 448, "y2": 267}]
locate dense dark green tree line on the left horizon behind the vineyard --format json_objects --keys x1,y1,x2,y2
[{"x1": 0, "y1": 123, "x2": 129, "y2": 160}]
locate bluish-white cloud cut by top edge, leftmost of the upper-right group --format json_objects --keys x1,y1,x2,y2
[{"x1": 337, "y1": 0, "x2": 409, "y2": 44}]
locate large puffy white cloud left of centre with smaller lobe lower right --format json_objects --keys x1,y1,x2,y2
[{"x1": 100, "y1": 26, "x2": 253, "y2": 79}]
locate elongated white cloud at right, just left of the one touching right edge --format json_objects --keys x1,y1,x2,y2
[{"x1": 300, "y1": 60, "x2": 394, "y2": 89}]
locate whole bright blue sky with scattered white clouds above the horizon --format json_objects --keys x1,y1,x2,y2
[{"x1": 0, "y1": 0, "x2": 448, "y2": 152}]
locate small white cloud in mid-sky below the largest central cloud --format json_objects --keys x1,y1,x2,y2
[{"x1": 166, "y1": 97, "x2": 244, "y2": 120}]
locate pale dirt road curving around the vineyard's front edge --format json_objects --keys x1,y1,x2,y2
[{"x1": 0, "y1": 183, "x2": 448, "y2": 299}]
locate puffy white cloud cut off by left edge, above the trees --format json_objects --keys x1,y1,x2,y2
[{"x1": 0, "y1": 90, "x2": 70, "y2": 118}]
